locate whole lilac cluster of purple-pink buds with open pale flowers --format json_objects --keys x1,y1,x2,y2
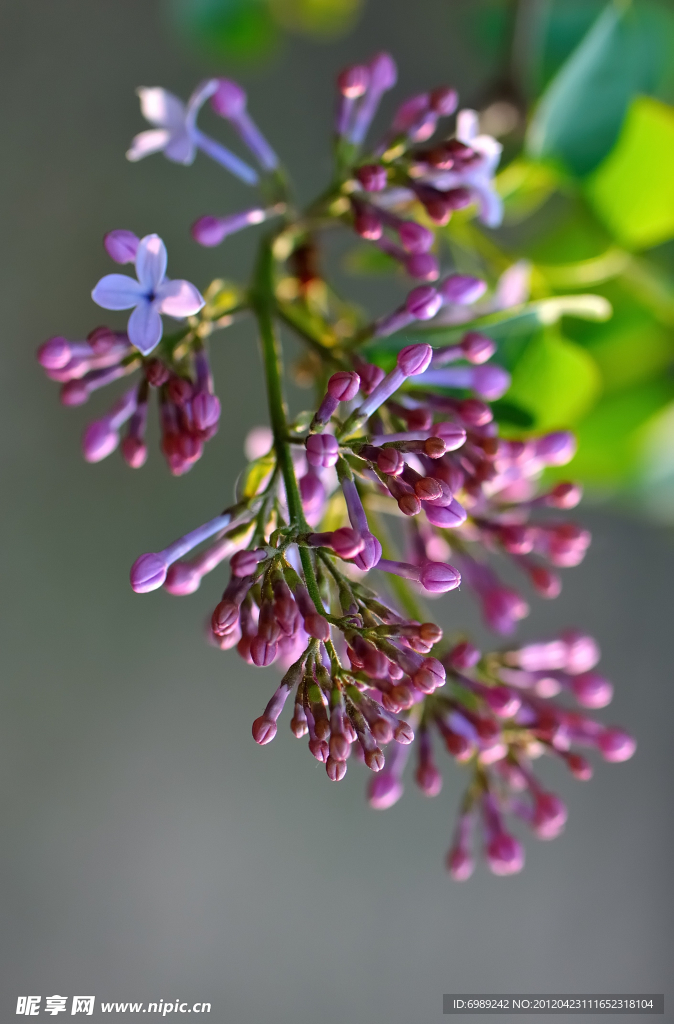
[{"x1": 38, "y1": 53, "x2": 635, "y2": 879}]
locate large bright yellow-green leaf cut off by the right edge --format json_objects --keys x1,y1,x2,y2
[{"x1": 586, "y1": 96, "x2": 674, "y2": 249}]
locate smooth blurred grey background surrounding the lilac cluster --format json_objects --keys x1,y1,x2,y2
[{"x1": 0, "y1": 0, "x2": 674, "y2": 1024}]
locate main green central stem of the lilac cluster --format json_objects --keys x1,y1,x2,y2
[{"x1": 251, "y1": 238, "x2": 325, "y2": 615}]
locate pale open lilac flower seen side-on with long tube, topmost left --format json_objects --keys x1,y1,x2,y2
[{"x1": 126, "y1": 78, "x2": 258, "y2": 185}]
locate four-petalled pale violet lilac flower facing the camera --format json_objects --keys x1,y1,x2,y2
[{"x1": 91, "y1": 234, "x2": 204, "y2": 355}]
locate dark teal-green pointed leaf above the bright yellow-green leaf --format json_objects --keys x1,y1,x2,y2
[{"x1": 526, "y1": 3, "x2": 663, "y2": 176}]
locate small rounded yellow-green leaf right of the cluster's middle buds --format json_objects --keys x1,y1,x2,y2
[{"x1": 508, "y1": 331, "x2": 601, "y2": 430}]
